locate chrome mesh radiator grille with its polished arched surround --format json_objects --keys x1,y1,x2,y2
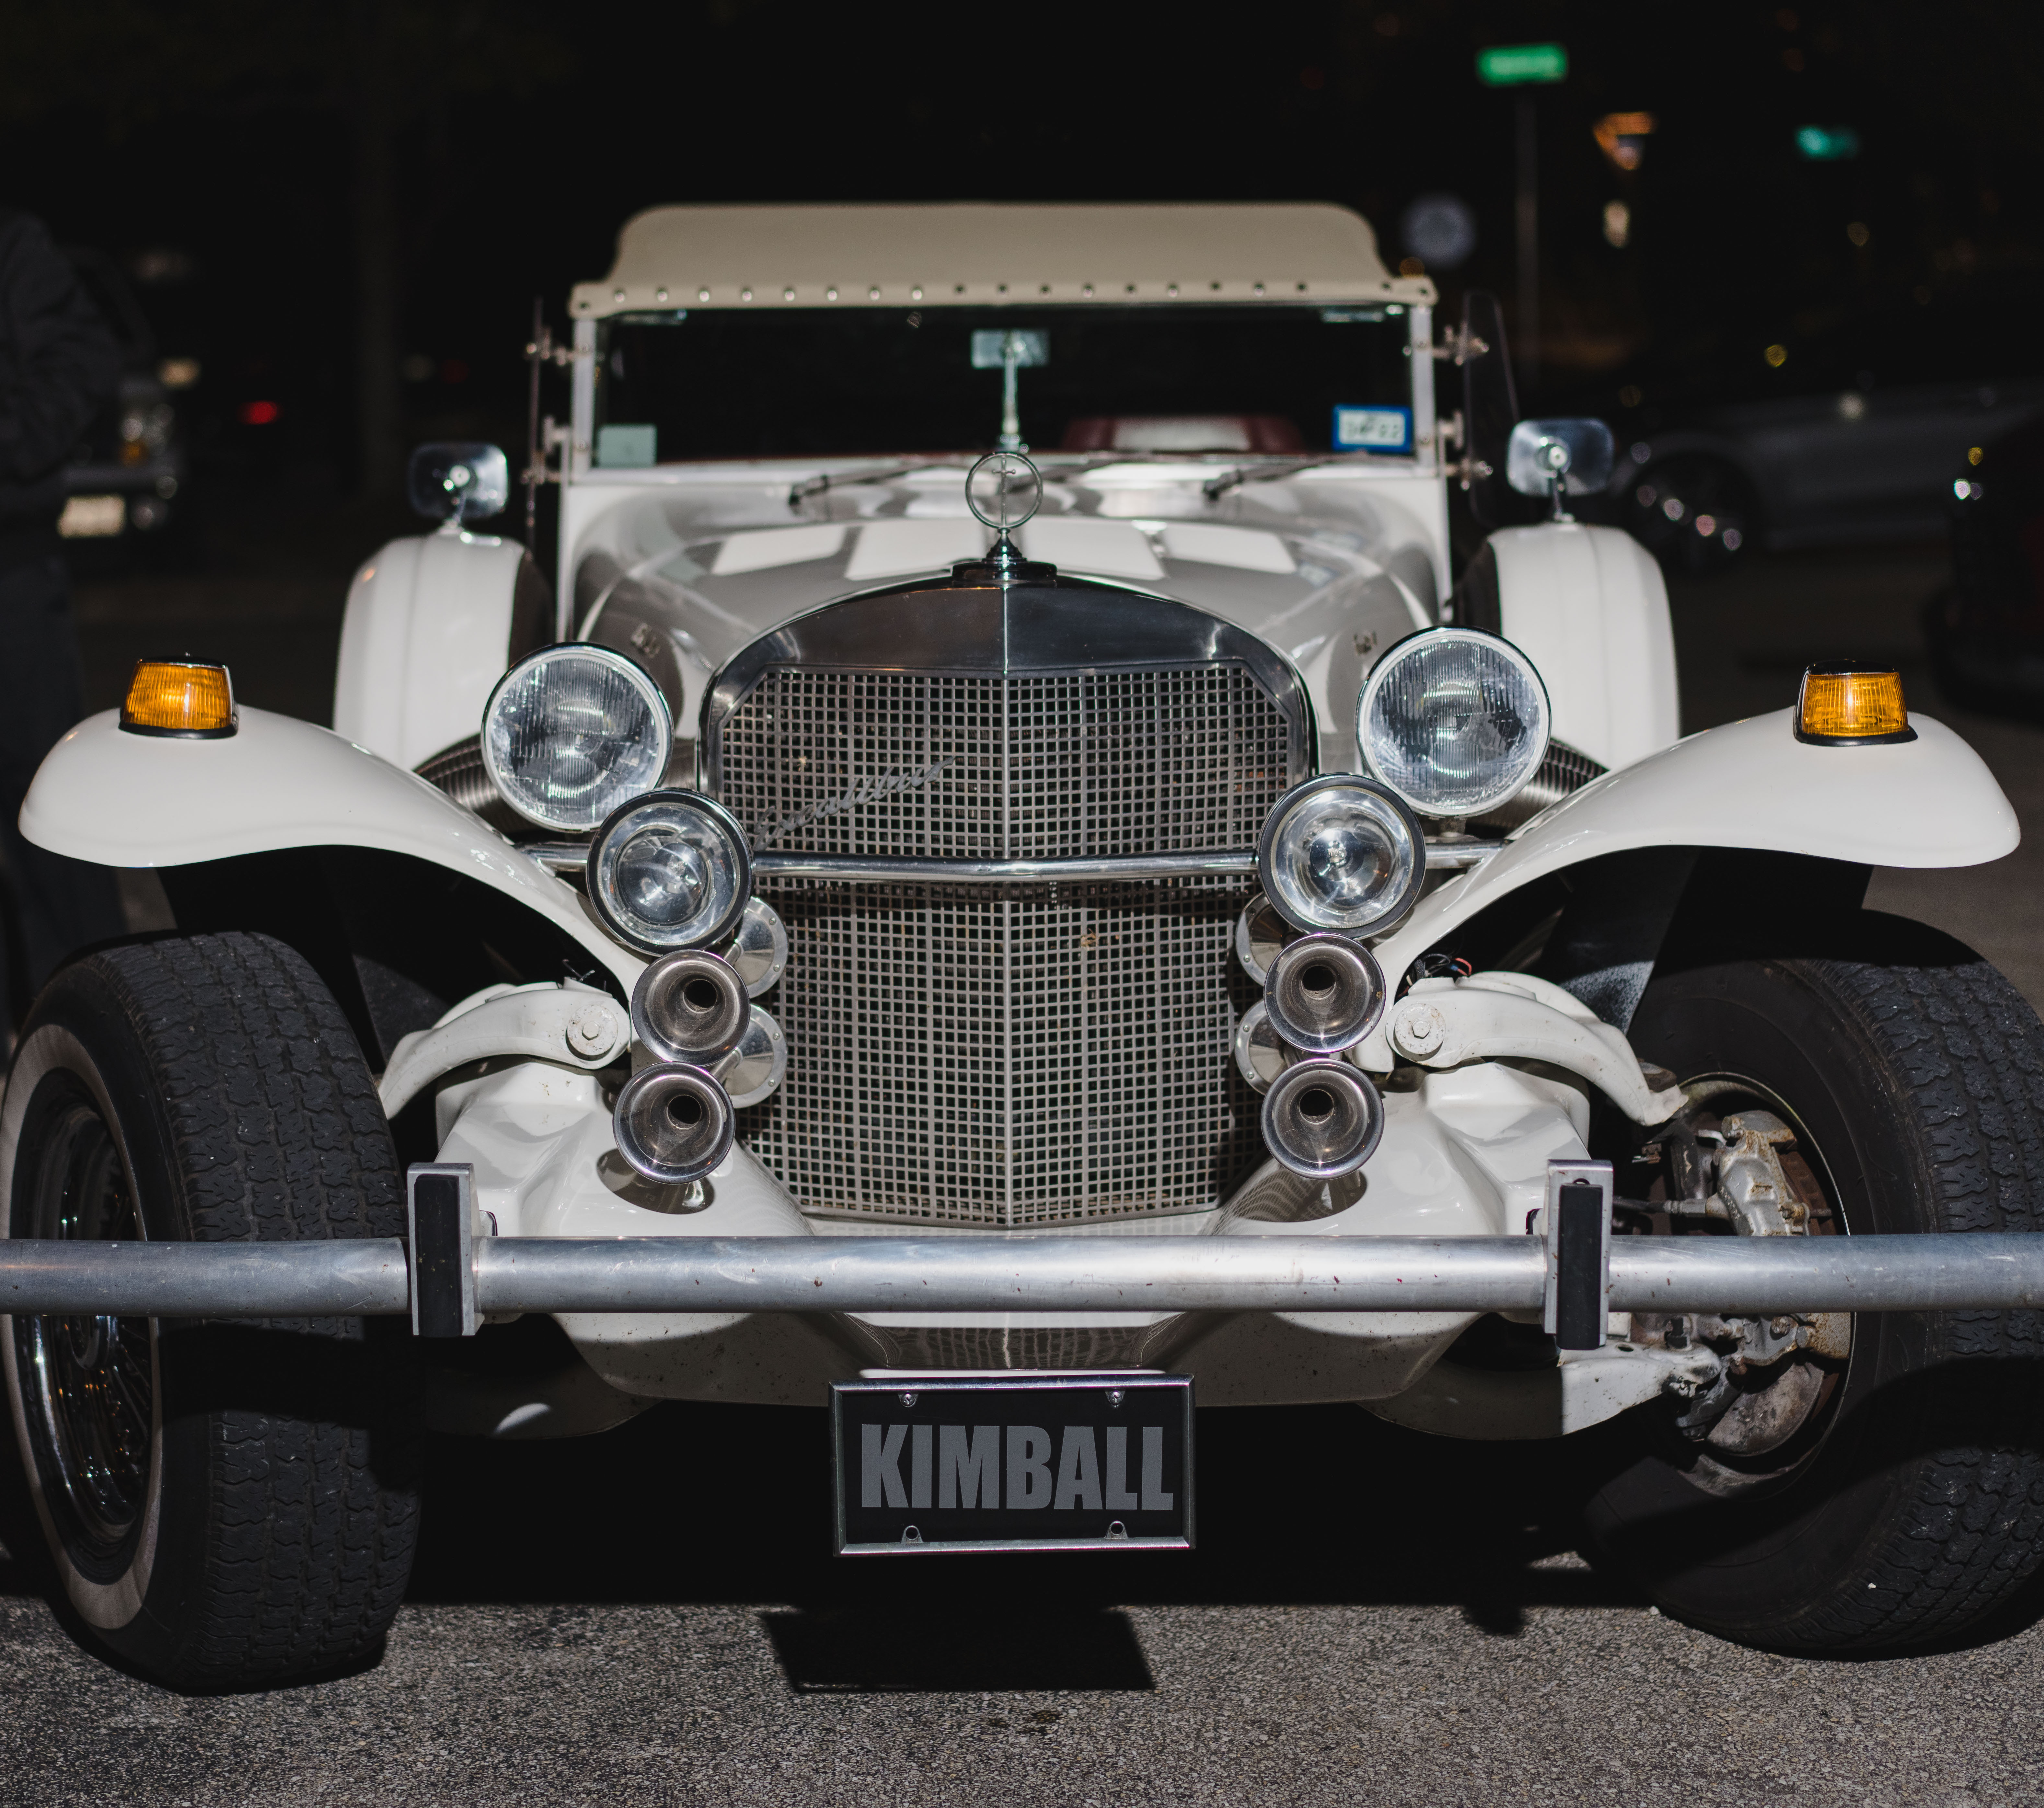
[{"x1": 703, "y1": 584, "x2": 1312, "y2": 1228}]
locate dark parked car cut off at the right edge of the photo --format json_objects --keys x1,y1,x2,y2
[{"x1": 1923, "y1": 419, "x2": 2044, "y2": 715}]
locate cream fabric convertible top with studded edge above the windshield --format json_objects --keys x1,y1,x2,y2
[{"x1": 572, "y1": 202, "x2": 1435, "y2": 319}]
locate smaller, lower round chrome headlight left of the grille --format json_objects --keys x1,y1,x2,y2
[{"x1": 587, "y1": 791, "x2": 752, "y2": 954}]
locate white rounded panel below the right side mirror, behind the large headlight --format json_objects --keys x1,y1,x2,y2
[{"x1": 1490, "y1": 521, "x2": 1680, "y2": 766}]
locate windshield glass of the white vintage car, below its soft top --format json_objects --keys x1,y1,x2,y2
[{"x1": 597, "y1": 304, "x2": 1413, "y2": 466}]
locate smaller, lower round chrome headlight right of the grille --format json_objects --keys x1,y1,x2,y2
[{"x1": 1257, "y1": 772, "x2": 1427, "y2": 936}]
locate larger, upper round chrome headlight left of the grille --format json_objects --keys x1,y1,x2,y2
[{"x1": 482, "y1": 644, "x2": 675, "y2": 833}]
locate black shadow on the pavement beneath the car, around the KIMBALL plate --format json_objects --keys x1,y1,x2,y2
[{"x1": 411, "y1": 1403, "x2": 1637, "y2": 1651}]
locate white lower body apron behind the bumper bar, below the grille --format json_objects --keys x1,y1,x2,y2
[{"x1": 437, "y1": 1038, "x2": 1588, "y2": 1405}]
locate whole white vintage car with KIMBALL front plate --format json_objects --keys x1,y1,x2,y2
[{"x1": 0, "y1": 206, "x2": 2044, "y2": 1688}]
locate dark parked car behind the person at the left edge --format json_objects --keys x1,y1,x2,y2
[{"x1": 57, "y1": 245, "x2": 198, "y2": 539}]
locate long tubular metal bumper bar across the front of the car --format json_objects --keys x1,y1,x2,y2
[{"x1": 0, "y1": 1232, "x2": 2044, "y2": 1328}]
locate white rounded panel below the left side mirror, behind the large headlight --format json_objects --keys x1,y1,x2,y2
[{"x1": 333, "y1": 533, "x2": 525, "y2": 770}]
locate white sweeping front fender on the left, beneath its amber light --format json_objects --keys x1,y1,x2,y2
[{"x1": 20, "y1": 709, "x2": 646, "y2": 991}]
